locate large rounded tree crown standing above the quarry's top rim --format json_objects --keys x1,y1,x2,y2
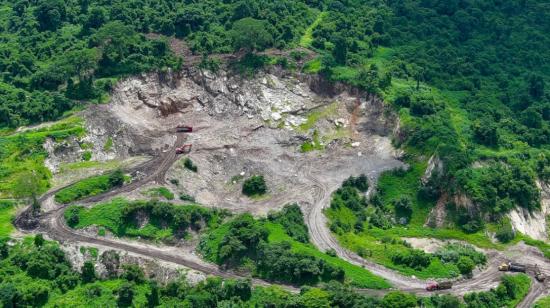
[{"x1": 231, "y1": 17, "x2": 273, "y2": 53}]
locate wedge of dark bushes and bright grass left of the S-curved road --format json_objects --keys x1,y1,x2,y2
[{"x1": 199, "y1": 206, "x2": 389, "y2": 289}]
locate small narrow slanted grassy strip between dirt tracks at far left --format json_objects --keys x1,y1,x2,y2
[{"x1": 55, "y1": 170, "x2": 125, "y2": 204}]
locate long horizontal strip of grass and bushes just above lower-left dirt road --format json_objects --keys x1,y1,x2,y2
[{"x1": 65, "y1": 199, "x2": 227, "y2": 242}]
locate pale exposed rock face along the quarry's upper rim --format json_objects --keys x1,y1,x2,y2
[{"x1": 105, "y1": 68, "x2": 396, "y2": 136}]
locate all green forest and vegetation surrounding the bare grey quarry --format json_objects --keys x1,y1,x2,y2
[{"x1": 0, "y1": 0, "x2": 550, "y2": 308}]
